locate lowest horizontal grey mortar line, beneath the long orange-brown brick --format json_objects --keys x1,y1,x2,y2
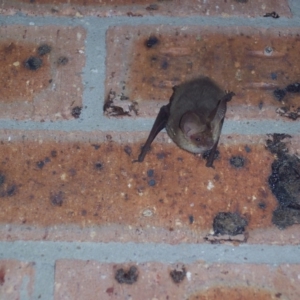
[{"x1": 0, "y1": 241, "x2": 300, "y2": 264}]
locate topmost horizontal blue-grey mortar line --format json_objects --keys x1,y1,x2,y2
[{"x1": 0, "y1": 13, "x2": 300, "y2": 29}]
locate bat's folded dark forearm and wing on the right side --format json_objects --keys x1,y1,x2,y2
[{"x1": 206, "y1": 92, "x2": 235, "y2": 168}]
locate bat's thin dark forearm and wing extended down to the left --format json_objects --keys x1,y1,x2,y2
[{"x1": 137, "y1": 102, "x2": 173, "y2": 162}]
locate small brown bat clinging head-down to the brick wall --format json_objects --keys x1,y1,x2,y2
[{"x1": 137, "y1": 77, "x2": 234, "y2": 167}]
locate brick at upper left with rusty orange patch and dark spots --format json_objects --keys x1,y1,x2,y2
[{"x1": 0, "y1": 25, "x2": 85, "y2": 121}]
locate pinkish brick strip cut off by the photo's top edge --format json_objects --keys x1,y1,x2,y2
[{"x1": 1, "y1": 0, "x2": 291, "y2": 17}]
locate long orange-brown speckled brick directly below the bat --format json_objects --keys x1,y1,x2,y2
[{"x1": 0, "y1": 133, "x2": 299, "y2": 242}]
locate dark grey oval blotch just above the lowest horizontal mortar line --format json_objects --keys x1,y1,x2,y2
[{"x1": 213, "y1": 212, "x2": 248, "y2": 235}]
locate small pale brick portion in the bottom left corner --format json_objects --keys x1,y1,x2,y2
[{"x1": 0, "y1": 260, "x2": 35, "y2": 300}]
